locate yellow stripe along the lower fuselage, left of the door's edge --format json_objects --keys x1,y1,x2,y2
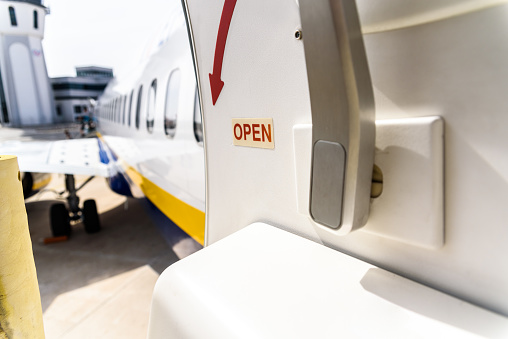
[{"x1": 126, "y1": 166, "x2": 205, "y2": 245}]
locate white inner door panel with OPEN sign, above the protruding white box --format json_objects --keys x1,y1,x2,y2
[{"x1": 159, "y1": 0, "x2": 508, "y2": 328}]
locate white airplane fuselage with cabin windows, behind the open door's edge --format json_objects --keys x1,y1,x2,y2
[{"x1": 96, "y1": 9, "x2": 205, "y2": 243}]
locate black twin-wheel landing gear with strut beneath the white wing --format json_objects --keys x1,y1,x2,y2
[{"x1": 49, "y1": 174, "x2": 101, "y2": 237}]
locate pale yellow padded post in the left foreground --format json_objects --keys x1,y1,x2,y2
[{"x1": 0, "y1": 155, "x2": 44, "y2": 339}]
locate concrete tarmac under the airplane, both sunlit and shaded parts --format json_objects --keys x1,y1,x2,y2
[{"x1": 26, "y1": 175, "x2": 178, "y2": 339}]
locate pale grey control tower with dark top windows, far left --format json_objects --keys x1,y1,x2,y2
[{"x1": 0, "y1": 0, "x2": 56, "y2": 127}]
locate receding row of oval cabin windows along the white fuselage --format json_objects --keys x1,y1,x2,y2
[{"x1": 99, "y1": 70, "x2": 203, "y2": 142}]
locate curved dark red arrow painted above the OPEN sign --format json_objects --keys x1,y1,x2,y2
[{"x1": 209, "y1": 0, "x2": 236, "y2": 106}]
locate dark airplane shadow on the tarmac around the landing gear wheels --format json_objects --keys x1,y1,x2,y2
[{"x1": 26, "y1": 195, "x2": 178, "y2": 311}]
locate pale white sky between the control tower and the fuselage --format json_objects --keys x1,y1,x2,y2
[{"x1": 42, "y1": 0, "x2": 181, "y2": 77}]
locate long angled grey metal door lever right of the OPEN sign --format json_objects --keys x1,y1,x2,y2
[{"x1": 299, "y1": 0, "x2": 376, "y2": 234}]
